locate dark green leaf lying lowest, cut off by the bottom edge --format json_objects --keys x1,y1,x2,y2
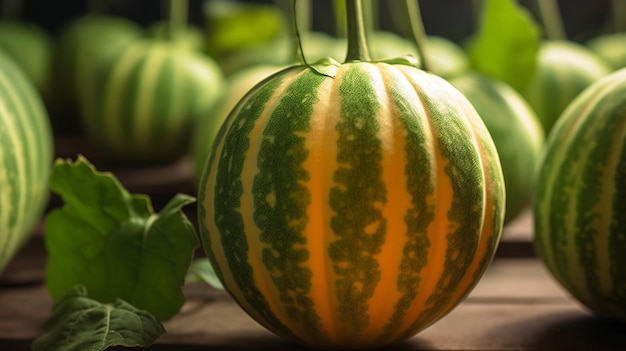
[{"x1": 32, "y1": 286, "x2": 165, "y2": 351}]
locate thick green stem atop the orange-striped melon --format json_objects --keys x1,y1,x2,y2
[{"x1": 345, "y1": 0, "x2": 370, "y2": 62}]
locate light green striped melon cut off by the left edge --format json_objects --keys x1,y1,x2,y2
[{"x1": 0, "y1": 52, "x2": 53, "y2": 272}]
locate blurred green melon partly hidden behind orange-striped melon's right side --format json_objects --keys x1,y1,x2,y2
[{"x1": 450, "y1": 72, "x2": 545, "y2": 224}]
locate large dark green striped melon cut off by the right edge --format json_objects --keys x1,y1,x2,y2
[{"x1": 534, "y1": 69, "x2": 626, "y2": 321}]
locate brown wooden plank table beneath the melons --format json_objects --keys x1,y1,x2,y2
[{"x1": 0, "y1": 139, "x2": 626, "y2": 351}]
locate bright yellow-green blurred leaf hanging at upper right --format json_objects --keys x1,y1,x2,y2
[{"x1": 467, "y1": 0, "x2": 541, "y2": 92}]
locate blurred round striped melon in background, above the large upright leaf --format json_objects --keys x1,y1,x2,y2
[{"x1": 82, "y1": 39, "x2": 223, "y2": 163}]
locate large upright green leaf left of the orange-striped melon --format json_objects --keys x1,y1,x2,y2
[{"x1": 45, "y1": 157, "x2": 198, "y2": 321}]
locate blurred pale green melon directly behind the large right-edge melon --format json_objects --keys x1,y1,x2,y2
[{"x1": 522, "y1": 40, "x2": 611, "y2": 133}]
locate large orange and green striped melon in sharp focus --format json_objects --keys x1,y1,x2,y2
[{"x1": 198, "y1": 60, "x2": 505, "y2": 349}]
